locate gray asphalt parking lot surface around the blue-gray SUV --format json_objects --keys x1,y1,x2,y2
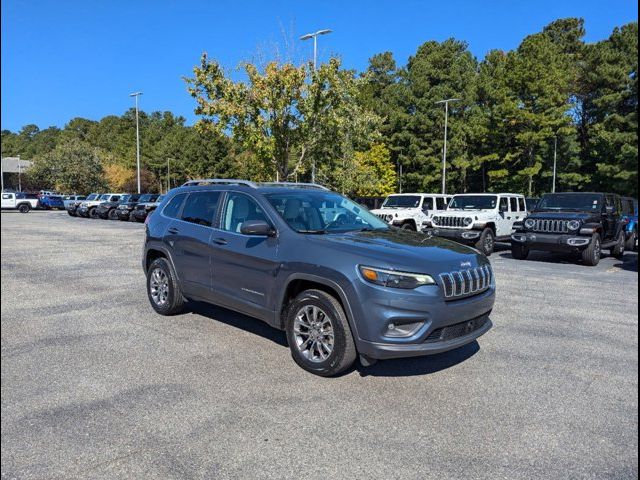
[{"x1": 1, "y1": 212, "x2": 638, "y2": 479}]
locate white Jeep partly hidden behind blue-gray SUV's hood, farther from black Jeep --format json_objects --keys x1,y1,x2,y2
[{"x1": 371, "y1": 193, "x2": 451, "y2": 231}]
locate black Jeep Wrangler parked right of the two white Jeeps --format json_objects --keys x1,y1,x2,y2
[{"x1": 511, "y1": 193, "x2": 625, "y2": 266}]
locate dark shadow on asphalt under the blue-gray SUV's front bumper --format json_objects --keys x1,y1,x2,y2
[{"x1": 356, "y1": 341, "x2": 480, "y2": 377}]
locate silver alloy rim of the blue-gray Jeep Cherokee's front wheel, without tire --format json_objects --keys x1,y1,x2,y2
[{"x1": 293, "y1": 305, "x2": 334, "y2": 363}]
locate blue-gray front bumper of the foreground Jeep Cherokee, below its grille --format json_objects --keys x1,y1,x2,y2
[{"x1": 348, "y1": 281, "x2": 495, "y2": 359}]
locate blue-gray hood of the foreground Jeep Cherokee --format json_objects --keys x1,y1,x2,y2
[{"x1": 309, "y1": 228, "x2": 489, "y2": 274}]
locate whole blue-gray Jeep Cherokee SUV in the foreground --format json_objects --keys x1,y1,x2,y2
[{"x1": 142, "y1": 179, "x2": 495, "y2": 376}]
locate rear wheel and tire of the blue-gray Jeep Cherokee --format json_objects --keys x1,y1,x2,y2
[{"x1": 147, "y1": 258, "x2": 184, "y2": 316}]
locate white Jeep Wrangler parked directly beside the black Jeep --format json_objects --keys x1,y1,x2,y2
[{"x1": 430, "y1": 193, "x2": 527, "y2": 255}]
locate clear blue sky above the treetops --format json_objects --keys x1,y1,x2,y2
[{"x1": 2, "y1": 0, "x2": 638, "y2": 131}]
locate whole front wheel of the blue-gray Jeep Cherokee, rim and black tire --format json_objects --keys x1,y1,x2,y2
[{"x1": 285, "y1": 290, "x2": 357, "y2": 377}]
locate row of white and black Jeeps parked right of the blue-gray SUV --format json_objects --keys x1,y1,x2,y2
[{"x1": 372, "y1": 192, "x2": 638, "y2": 265}]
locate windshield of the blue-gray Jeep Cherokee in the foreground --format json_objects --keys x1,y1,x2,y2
[{"x1": 266, "y1": 190, "x2": 389, "y2": 233}]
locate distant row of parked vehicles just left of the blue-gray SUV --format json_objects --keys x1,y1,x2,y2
[{"x1": 66, "y1": 193, "x2": 162, "y2": 222}]
